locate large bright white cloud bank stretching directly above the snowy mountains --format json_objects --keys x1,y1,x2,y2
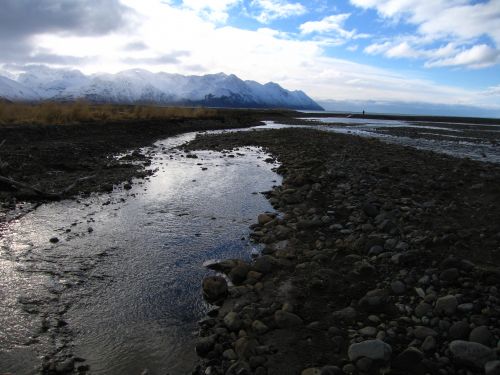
[{"x1": 4, "y1": 0, "x2": 498, "y2": 110}]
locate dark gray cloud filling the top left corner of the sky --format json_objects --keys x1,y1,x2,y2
[{"x1": 0, "y1": 0, "x2": 133, "y2": 65}]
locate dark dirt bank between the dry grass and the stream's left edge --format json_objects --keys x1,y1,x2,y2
[{"x1": 0, "y1": 110, "x2": 292, "y2": 214}]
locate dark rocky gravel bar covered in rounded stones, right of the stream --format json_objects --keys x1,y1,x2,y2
[{"x1": 185, "y1": 129, "x2": 500, "y2": 375}]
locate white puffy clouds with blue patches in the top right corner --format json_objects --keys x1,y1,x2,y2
[{"x1": 351, "y1": 0, "x2": 500, "y2": 68}]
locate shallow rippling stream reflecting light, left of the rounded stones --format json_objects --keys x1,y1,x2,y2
[{"x1": 0, "y1": 133, "x2": 281, "y2": 374}]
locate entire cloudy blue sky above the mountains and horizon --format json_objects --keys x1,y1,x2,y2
[{"x1": 0, "y1": 0, "x2": 500, "y2": 111}]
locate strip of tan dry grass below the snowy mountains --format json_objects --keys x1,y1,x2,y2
[{"x1": 0, "y1": 101, "x2": 217, "y2": 125}]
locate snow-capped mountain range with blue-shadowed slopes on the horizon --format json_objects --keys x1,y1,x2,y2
[{"x1": 0, "y1": 66, "x2": 322, "y2": 110}]
